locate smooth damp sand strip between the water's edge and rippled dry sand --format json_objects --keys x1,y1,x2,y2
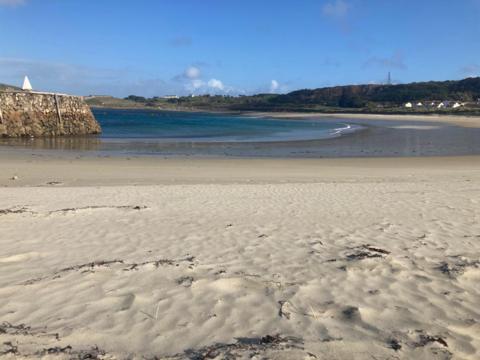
[{"x1": 0, "y1": 151, "x2": 480, "y2": 187}]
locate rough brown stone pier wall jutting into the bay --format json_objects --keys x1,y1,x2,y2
[{"x1": 0, "y1": 91, "x2": 101, "y2": 137}]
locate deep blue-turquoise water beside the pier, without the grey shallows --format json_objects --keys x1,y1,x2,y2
[{"x1": 94, "y1": 109, "x2": 354, "y2": 143}]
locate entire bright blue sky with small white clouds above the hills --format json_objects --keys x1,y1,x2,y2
[{"x1": 0, "y1": 0, "x2": 480, "y2": 96}]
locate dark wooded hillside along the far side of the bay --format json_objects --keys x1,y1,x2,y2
[{"x1": 87, "y1": 77, "x2": 480, "y2": 113}]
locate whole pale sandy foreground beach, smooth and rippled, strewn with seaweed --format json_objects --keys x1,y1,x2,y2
[{"x1": 0, "y1": 154, "x2": 480, "y2": 359}]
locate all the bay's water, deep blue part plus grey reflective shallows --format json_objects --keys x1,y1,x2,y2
[{"x1": 0, "y1": 108, "x2": 480, "y2": 158}]
